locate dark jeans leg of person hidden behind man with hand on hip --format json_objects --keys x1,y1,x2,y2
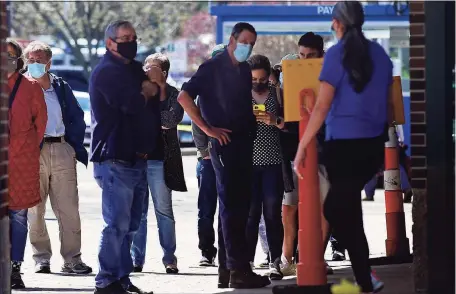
[{"x1": 196, "y1": 159, "x2": 217, "y2": 259}]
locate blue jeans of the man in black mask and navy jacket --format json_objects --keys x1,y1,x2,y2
[{"x1": 94, "y1": 160, "x2": 147, "y2": 288}]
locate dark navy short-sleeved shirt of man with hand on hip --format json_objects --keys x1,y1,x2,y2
[{"x1": 182, "y1": 50, "x2": 256, "y2": 136}]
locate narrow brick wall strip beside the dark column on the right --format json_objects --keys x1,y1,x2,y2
[{"x1": 410, "y1": 1, "x2": 427, "y2": 189}]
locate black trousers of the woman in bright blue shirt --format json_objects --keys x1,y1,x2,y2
[{"x1": 323, "y1": 136, "x2": 385, "y2": 292}]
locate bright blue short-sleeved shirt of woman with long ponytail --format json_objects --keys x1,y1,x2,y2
[{"x1": 320, "y1": 41, "x2": 393, "y2": 140}]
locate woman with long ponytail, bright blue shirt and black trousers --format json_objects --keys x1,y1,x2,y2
[{"x1": 294, "y1": 1, "x2": 393, "y2": 293}]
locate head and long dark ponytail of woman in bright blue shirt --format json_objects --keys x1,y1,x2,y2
[{"x1": 333, "y1": 1, "x2": 373, "y2": 93}]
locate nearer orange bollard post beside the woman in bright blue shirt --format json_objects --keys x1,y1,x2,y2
[{"x1": 297, "y1": 89, "x2": 327, "y2": 286}]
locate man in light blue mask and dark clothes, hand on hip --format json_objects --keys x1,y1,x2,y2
[{"x1": 178, "y1": 23, "x2": 270, "y2": 288}]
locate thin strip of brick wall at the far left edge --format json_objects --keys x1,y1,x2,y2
[{"x1": 0, "y1": 1, "x2": 8, "y2": 219}]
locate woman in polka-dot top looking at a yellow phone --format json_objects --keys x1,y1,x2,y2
[{"x1": 246, "y1": 55, "x2": 284, "y2": 280}]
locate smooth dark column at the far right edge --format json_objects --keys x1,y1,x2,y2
[{"x1": 424, "y1": 1, "x2": 455, "y2": 293}]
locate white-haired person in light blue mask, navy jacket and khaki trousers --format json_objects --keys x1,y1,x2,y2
[{"x1": 24, "y1": 41, "x2": 92, "y2": 274}]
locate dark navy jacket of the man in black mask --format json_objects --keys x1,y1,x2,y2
[{"x1": 89, "y1": 51, "x2": 162, "y2": 162}]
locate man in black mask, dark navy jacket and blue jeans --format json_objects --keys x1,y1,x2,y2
[{"x1": 89, "y1": 21, "x2": 162, "y2": 294}]
